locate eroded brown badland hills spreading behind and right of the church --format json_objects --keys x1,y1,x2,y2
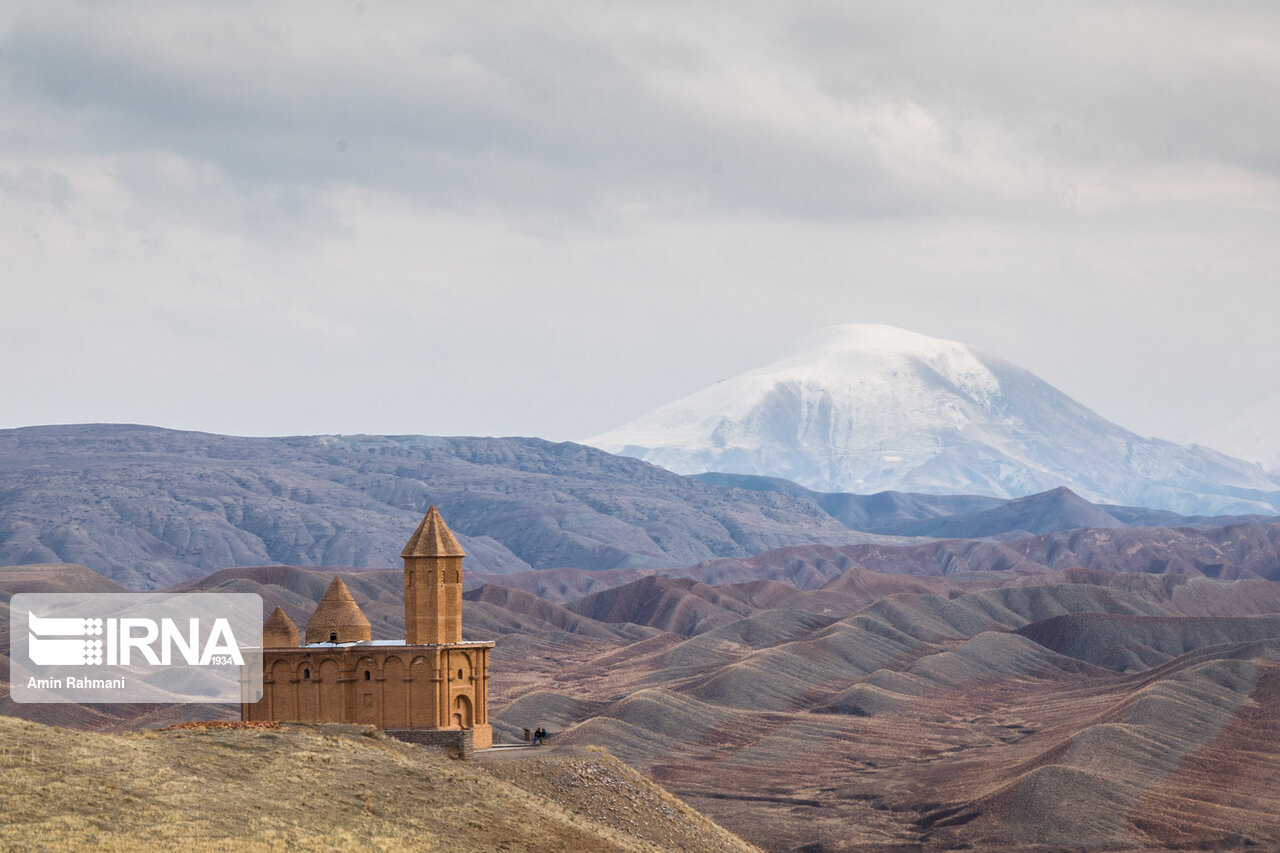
[{"x1": 10, "y1": 555, "x2": 1280, "y2": 853}]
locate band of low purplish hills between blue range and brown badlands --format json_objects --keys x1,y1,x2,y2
[{"x1": 468, "y1": 523, "x2": 1280, "y2": 607}]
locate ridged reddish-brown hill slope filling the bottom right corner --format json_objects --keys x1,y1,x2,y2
[{"x1": 919, "y1": 640, "x2": 1280, "y2": 849}]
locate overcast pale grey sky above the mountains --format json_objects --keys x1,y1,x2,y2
[{"x1": 0, "y1": 0, "x2": 1280, "y2": 466}]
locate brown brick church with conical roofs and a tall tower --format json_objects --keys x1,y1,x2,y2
[{"x1": 241, "y1": 506, "x2": 494, "y2": 749}]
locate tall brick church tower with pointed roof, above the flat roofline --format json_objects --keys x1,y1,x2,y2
[{"x1": 401, "y1": 506, "x2": 466, "y2": 646}]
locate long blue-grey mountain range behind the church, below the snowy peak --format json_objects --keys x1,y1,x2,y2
[{"x1": 0, "y1": 425, "x2": 1265, "y2": 594}]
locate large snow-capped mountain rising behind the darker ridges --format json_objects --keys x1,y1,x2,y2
[{"x1": 584, "y1": 325, "x2": 1280, "y2": 514}]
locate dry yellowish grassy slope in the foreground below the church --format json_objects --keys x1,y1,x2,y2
[{"x1": 0, "y1": 717, "x2": 755, "y2": 853}]
